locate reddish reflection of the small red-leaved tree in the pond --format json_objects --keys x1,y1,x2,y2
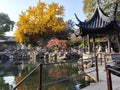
[{"x1": 48, "y1": 63, "x2": 78, "y2": 80}]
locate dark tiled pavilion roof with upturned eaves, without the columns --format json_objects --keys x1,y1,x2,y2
[{"x1": 75, "y1": 5, "x2": 120, "y2": 36}]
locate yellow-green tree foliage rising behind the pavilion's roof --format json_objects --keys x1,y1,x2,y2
[{"x1": 83, "y1": 0, "x2": 120, "y2": 19}]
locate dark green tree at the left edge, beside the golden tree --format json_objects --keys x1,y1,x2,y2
[{"x1": 0, "y1": 13, "x2": 15, "y2": 38}]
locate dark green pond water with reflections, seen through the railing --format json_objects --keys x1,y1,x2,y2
[{"x1": 0, "y1": 61, "x2": 89, "y2": 90}]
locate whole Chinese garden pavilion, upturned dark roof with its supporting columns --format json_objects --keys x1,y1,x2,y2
[{"x1": 75, "y1": 3, "x2": 120, "y2": 53}]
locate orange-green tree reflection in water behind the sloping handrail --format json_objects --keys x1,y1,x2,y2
[{"x1": 15, "y1": 67, "x2": 39, "y2": 90}]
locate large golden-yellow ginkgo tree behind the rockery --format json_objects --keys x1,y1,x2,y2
[{"x1": 14, "y1": 1, "x2": 66, "y2": 43}]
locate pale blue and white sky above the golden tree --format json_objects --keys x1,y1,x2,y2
[{"x1": 0, "y1": 0, "x2": 86, "y2": 34}]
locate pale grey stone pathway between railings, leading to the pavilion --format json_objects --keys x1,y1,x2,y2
[{"x1": 81, "y1": 65, "x2": 120, "y2": 90}]
